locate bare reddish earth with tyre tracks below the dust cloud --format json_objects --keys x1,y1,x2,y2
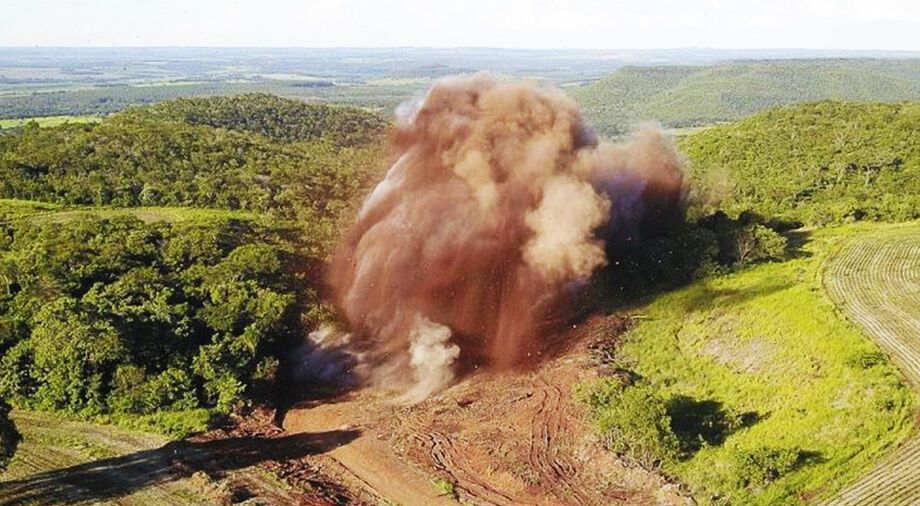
[{"x1": 284, "y1": 317, "x2": 688, "y2": 505}]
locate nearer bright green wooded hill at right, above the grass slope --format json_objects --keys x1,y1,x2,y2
[{"x1": 679, "y1": 101, "x2": 920, "y2": 224}]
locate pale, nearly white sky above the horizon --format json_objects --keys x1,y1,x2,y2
[{"x1": 0, "y1": 0, "x2": 920, "y2": 50}]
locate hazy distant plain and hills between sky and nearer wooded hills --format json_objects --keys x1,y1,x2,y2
[{"x1": 0, "y1": 48, "x2": 920, "y2": 126}]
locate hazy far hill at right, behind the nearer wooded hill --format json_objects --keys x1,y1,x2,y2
[{"x1": 569, "y1": 59, "x2": 920, "y2": 135}]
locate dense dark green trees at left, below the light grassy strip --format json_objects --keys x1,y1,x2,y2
[{"x1": 0, "y1": 215, "x2": 318, "y2": 434}]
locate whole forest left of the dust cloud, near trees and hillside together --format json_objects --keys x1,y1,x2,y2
[{"x1": 0, "y1": 95, "x2": 385, "y2": 434}]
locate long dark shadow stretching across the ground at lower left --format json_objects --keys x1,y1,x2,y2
[{"x1": 0, "y1": 430, "x2": 360, "y2": 505}]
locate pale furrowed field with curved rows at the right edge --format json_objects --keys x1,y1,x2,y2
[{"x1": 825, "y1": 224, "x2": 920, "y2": 506}]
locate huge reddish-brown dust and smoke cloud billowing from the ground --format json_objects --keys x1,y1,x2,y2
[{"x1": 330, "y1": 75, "x2": 684, "y2": 401}]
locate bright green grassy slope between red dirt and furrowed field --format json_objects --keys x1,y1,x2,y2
[{"x1": 594, "y1": 227, "x2": 916, "y2": 504}]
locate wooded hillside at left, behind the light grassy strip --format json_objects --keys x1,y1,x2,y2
[{"x1": 0, "y1": 95, "x2": 383, "y2": 229}]
